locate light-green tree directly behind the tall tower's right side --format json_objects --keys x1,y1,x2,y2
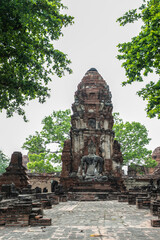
[{"x1": 113, "y1": 113, "x2": 157, "y2": 167}]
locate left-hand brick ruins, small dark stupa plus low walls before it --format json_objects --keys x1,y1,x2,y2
[{"x1": 0, "y1": 152, "x2": 60, "y2": 227}]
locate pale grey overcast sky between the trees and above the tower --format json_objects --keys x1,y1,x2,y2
[{"x1": 0, "y1": 0, "x2": 160, "y2": 157}]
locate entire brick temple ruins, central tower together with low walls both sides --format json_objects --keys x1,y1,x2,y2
[{"x1": 0, "y1": 68, "x2": 160, "y2": 227}]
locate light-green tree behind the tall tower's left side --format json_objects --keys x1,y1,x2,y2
[{"x1": 22, "y1": 109, "x2": 71, "y2": 172}]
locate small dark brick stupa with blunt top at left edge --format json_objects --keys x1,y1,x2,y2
[{"x1": 0, "y1": 152, "x2": 29, "y2": 190}]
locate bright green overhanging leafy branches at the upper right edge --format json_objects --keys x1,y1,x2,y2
[{"x1": 117, "y1": 0, "x2": 160, "y2": 119}]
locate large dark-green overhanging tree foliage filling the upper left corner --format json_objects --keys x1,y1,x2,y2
[{"x1": 0, "y1": 0, "x2": 73, "y2": 121}]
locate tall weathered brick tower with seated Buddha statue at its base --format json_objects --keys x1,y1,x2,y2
[{"x1": 61, "y1": 68, "x2": 124, "y2": 199}]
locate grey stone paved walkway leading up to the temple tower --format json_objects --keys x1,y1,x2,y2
[{"x1": 0, "y1": 201, "x2": 160, "y2": 240}]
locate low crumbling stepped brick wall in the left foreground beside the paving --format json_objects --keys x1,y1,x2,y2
[{"x1": 0, "y1": 195, "x2": 51, "y2": 227}]
